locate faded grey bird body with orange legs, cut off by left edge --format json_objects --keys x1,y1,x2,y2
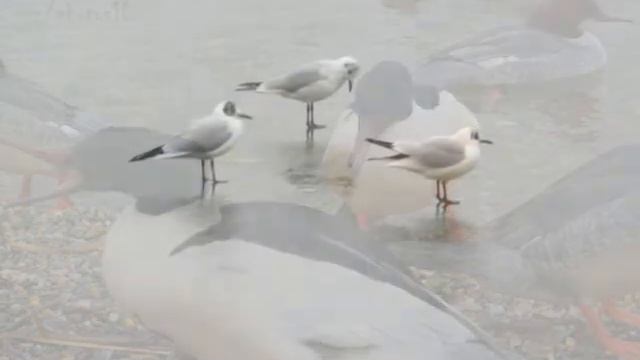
[{"x1": 0, "y1": 58, "x2": 110, "y2": 209}]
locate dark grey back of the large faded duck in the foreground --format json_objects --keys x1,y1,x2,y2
[{"x1": 171, "y1": 202, "x2": 510, "y2": 359}]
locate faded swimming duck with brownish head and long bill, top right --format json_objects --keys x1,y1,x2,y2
[{"x1": 420, "y1": 0, "x2": 630, "y2": 88}]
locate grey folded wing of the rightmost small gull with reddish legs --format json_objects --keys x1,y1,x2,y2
[{"x1": 406, "y1": 138, "x2": 464, "y2": 169}]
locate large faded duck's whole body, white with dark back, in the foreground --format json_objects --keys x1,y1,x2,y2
[{"x1": 102, "y1": 193, "x2": 516, "y2": 360}]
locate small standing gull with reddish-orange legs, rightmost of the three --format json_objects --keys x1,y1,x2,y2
[{"x1": 367, "y1": 127, "x2": 493, "y2": 206}]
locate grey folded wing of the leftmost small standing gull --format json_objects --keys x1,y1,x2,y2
[{"x1": 164, "y1": 121, "x2": 232, "y2": 153}]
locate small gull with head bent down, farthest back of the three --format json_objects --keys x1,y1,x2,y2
[{"x1": 236, "y1": 56, "x2": 360, "y2": 131}]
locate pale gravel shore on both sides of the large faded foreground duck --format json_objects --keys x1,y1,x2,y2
[{"x1": 0, "y1": 205, "x2": 628, "y2": 360}]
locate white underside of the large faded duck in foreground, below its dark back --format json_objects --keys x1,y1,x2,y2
[{"x1": 103, "y1": 204, "x2": 473, "y2": 360}]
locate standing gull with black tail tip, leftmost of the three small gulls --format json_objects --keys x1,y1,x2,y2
[{"x1": 129, "y1": 101, "x2": 251, "y2": 186}]
